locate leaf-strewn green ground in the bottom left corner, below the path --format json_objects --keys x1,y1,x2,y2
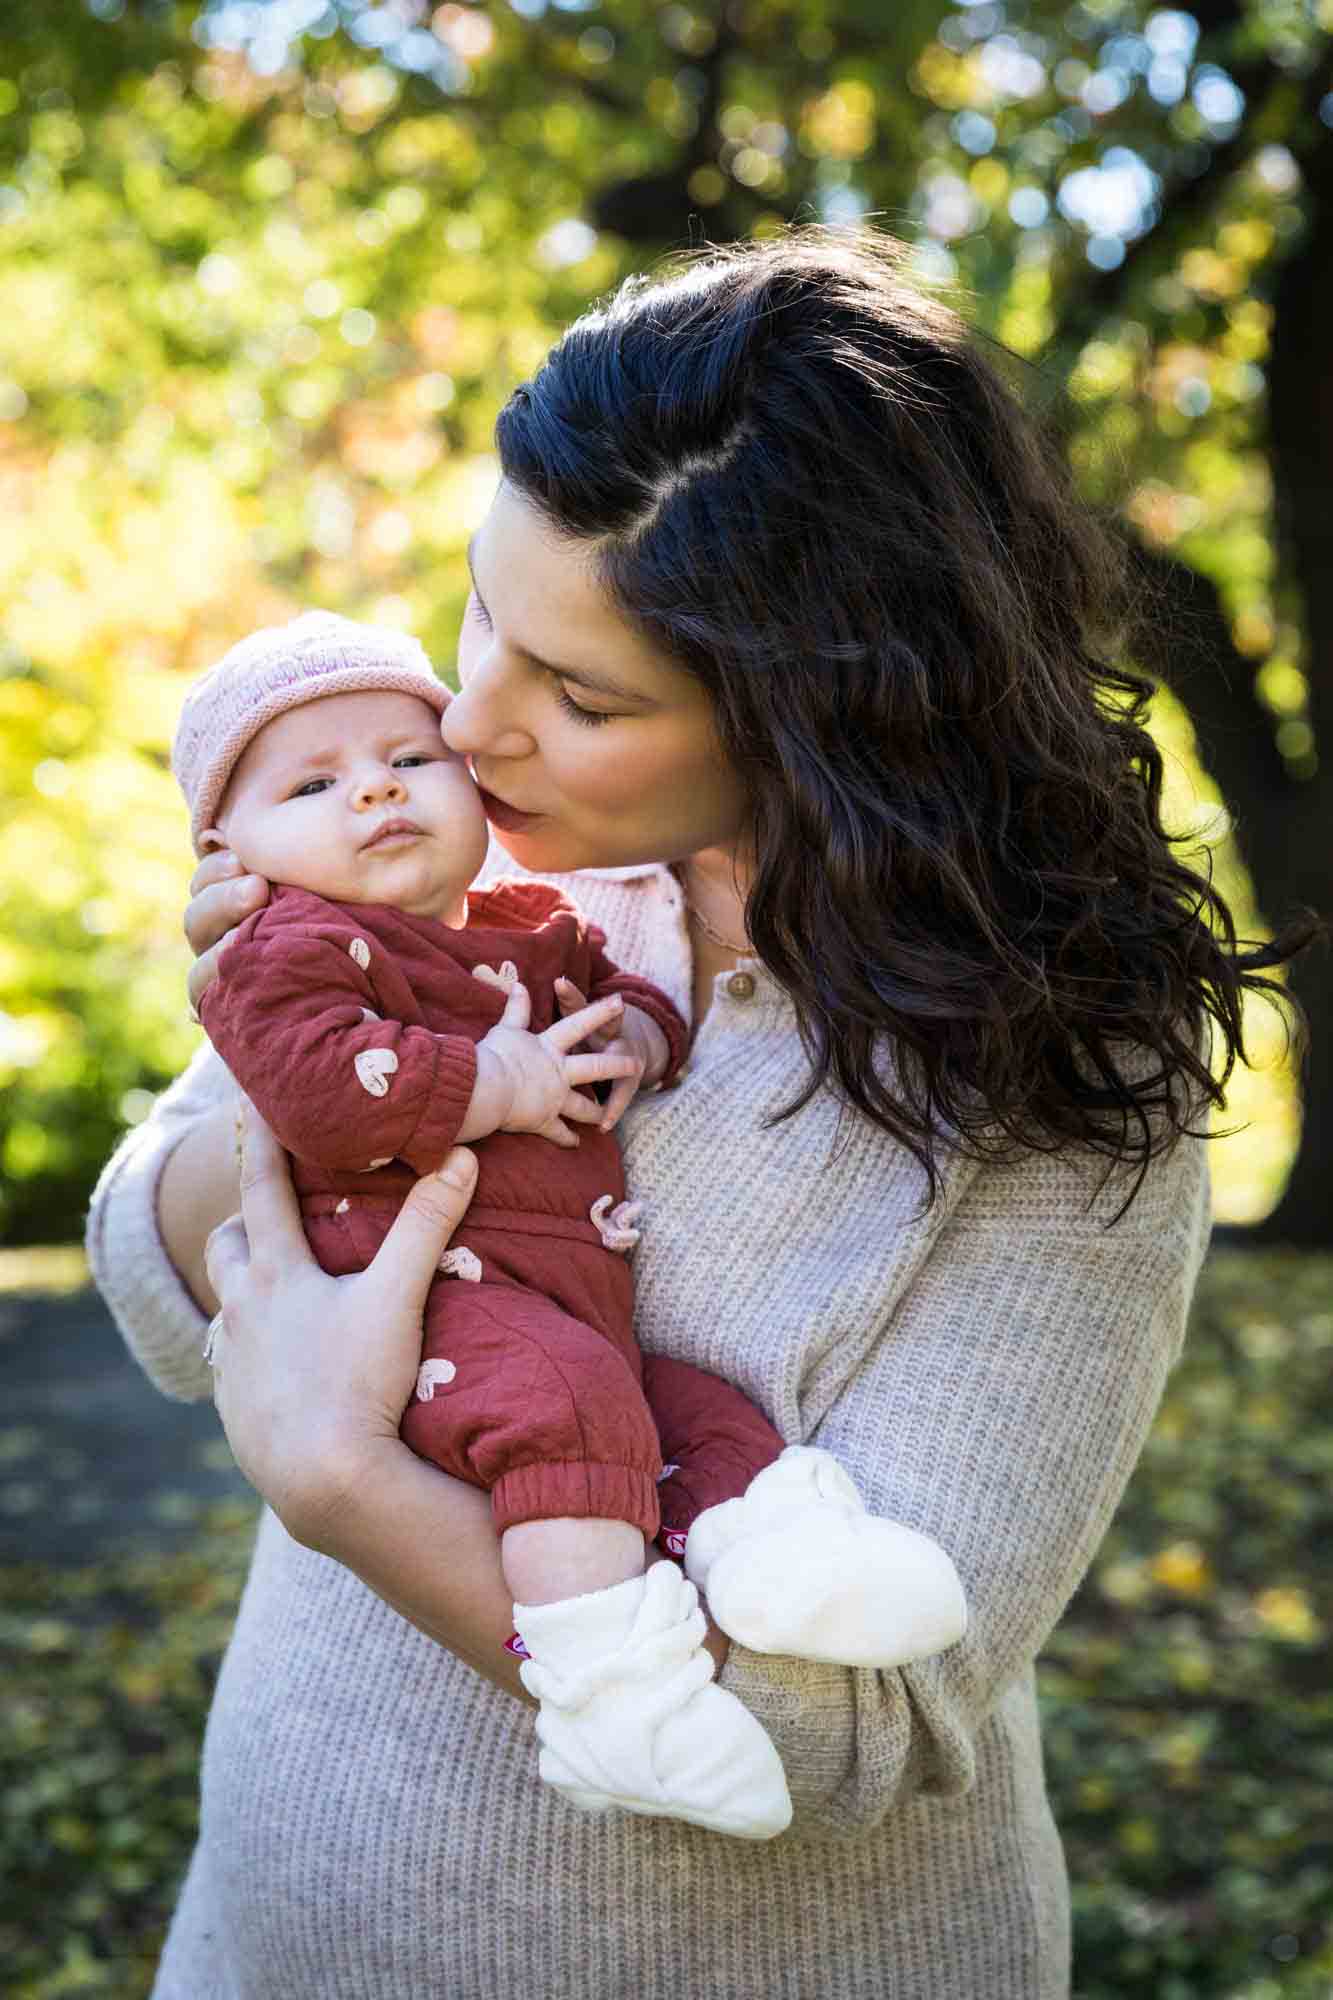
[{"x1": 0, "y1": 1502, "x2": 256, "y2": 2000}]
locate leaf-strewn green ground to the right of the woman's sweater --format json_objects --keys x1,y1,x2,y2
[{"x1": 1041, "y1": 1252, "x2": 1333, "y2": 2000}]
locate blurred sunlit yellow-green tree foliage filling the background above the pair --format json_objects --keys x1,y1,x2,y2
[{"x1": 0, "y1": 0, "x2": 1333, "y2": 1242}]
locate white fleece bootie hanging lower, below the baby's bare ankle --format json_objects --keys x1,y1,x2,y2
[{"x1": 514, "y1": 1562, "x2": 791, "y2": 1840}]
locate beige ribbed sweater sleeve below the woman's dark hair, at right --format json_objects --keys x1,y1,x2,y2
[{"x1": 721, "y1": 1138, "x2": 1209, "y2": 1834}]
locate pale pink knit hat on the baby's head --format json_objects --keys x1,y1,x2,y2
[{"x1": 172, "y1": 612, "x2": 448, "y2": 854}]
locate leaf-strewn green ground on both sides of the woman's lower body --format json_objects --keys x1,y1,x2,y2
[{"x1": 0, "y1": 1252, "x2": 1333, "y2": 2000}]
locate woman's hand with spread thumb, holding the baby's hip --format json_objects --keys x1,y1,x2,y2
[{"x1": 206, "y1": 1106, "x2": 476, "y2": 1548}]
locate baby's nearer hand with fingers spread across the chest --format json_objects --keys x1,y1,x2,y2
[{"x1": 458, "y1": 984, "x2": 634, "y2": 1146}]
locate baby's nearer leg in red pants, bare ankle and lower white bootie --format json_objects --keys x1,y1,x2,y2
[{"x1": 402, "y1": 1278, "x2": 791, "y2": 1840}]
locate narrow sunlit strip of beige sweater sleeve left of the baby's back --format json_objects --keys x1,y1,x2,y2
[{"x1": 86, "y1": 1046, "x2": 232, "y2": 1402}]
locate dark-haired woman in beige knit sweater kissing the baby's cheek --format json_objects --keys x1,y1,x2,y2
[{"x1": 90, "y1": 232, "x2": 1313, "y2": 2000}]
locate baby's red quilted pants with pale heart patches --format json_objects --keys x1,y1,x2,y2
[{"x1": 304, "y1": 1198, "x2": 783, "y2": 1554}]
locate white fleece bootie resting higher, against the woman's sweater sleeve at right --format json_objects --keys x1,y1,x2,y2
[{"x1": 685, "y1": 1444, "x2": 967, "y2": 1666}]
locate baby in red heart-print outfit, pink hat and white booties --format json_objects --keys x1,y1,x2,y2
[{"x1": 172, "y1": 612, "x2": 967, "y2": 1840}]
